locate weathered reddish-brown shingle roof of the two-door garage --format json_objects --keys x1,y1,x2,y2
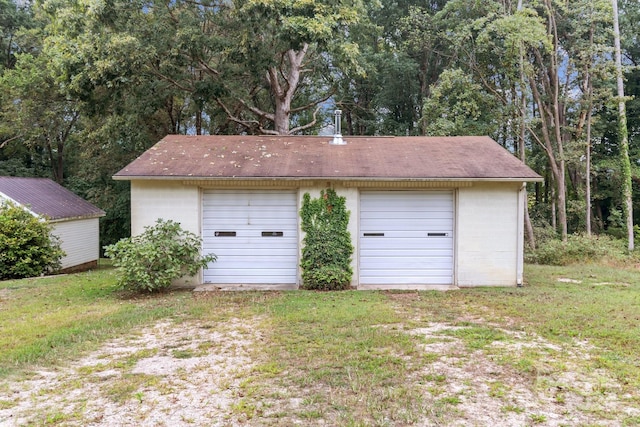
[{"x1": 114, "y1": 135, "x2": 541, "y2": 181}]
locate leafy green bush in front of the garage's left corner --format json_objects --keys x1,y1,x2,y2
[{"x1": 105, "y1": 219, "x2": 216, "y2": 292}]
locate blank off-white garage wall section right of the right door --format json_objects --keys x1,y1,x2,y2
[{"x1": 455, "y1": 183, "x2": 522, "y2": 286}]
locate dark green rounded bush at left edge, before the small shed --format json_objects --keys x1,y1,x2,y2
[{"x1": 0, "y1": 202, "x2": 65, "y2": 279}]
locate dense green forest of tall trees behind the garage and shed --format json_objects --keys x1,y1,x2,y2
[{"x1": 0, "y1": 0, "x2": 640, "y2": 251}]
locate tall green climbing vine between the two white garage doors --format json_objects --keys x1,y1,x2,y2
[{"x1": 300, "y1": 188, "x2": 353, "y2": 290}]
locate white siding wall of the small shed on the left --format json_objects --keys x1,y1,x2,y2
[{"x1": 52, "y1": 218, "x2": 100, "y2": 268}]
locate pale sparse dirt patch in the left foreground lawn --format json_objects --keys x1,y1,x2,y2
[{"x1": 0, "y1": 319, "x2": 261, "y2": 426}]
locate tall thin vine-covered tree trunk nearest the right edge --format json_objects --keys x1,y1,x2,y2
[{"x1": 612, "y1": 0, "x2": 634, "y2": 251}]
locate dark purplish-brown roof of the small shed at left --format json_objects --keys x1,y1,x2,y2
[{"x1": 0, "y1": 176, "x2": 105, "y2": 220}]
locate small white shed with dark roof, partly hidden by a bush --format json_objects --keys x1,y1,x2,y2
[{"x1": 0, "y1": 176, "x2": 105, "y2": 272}]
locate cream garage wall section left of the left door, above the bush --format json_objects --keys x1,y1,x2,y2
[{"x1": 131, "y1": 181, "x2": 200, "y2": 236}]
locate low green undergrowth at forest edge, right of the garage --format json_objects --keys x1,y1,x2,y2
[{"x1": 525, "y1": 234, "x2": 625, "y2": 265}]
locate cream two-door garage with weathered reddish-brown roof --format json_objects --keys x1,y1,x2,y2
[{"x1": 114, "y1": 135, "x2": 541, "y2": 289}]
